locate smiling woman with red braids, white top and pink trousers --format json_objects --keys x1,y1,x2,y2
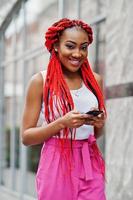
[{"x1": 21, "y1": 18, "x2": 106, "y2": 200}]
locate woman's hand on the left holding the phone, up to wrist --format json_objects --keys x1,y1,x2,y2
[{"x1": 61, "y1": 110, "x2": 88, "y2": 128}]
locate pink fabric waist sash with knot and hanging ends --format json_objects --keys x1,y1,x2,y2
[{"x1": 45, "y1": 135, "x2": 105, "y2": 180}]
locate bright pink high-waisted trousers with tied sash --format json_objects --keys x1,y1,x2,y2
[{"x1": 36, "y1": 135, "x2": 106, "y2": 200}]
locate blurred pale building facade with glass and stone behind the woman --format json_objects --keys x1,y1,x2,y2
[{"x1": 0, "y1": 0, "x2": 133, "y2": 200}]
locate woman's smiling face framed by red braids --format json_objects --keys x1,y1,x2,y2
[{"x1": 57, "y1": 27, "x2": 89, "y2": 72}]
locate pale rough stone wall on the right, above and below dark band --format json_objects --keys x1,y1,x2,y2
[{"x1": 106, "y1": 0, "x2": 133, "y2": 200}]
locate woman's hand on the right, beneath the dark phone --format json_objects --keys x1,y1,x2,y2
[{"x1": 85, "y1": 113, "x2": 106, "y2": 128}]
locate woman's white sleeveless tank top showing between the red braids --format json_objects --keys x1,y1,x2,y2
[{"x1": 38, "y1": 71, "x2": 98, "y2": 140}]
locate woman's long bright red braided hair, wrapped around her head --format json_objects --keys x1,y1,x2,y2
[{"x1": 44, "y1": 18, "x2": 105, "y2": 141}]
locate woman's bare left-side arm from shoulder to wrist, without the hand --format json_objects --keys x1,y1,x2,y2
[{"x1": 21, "y1": 74, "x2": 66, "y2": 145}]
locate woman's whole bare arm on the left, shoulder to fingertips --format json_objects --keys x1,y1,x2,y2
[{"x1": 21, "y1": 74, "x2": 87, "y2": 145}]
